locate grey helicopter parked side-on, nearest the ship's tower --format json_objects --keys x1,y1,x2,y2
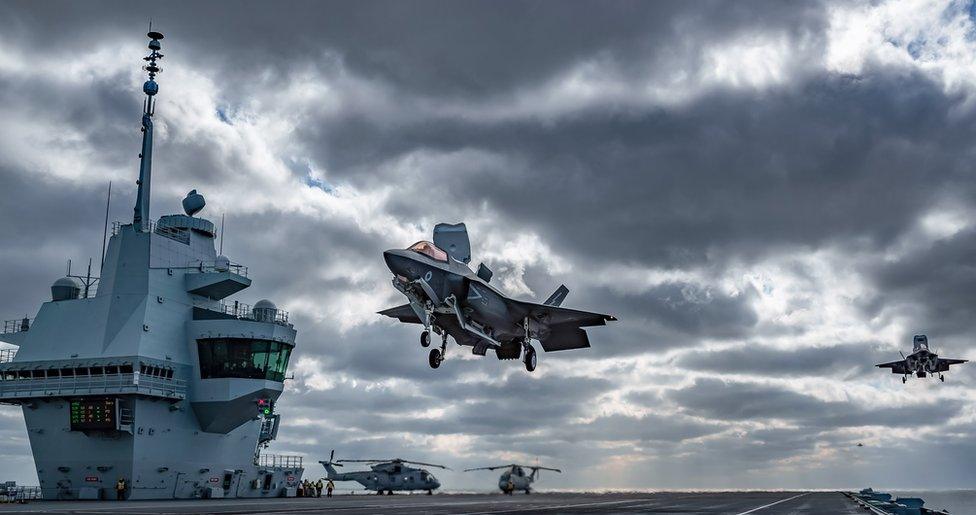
[{"x1": 319, "y1": 450, "x2": 450, "y2": 495}]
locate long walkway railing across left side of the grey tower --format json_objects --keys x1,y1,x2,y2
[{"x1": 0, "y1": 371, "x2": 186, "y2": 399}]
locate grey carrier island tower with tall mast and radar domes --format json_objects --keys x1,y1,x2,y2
[{"x1": 0, "y1": 32, "x2": 303, "y2": 499}]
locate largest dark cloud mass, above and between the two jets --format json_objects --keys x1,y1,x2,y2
[{"x1": 345, "y1": 71, "x2": 973, "y2": 267}]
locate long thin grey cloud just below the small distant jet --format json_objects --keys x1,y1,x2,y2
[{"x1": 667, "y1": 379, "x2": 963, "y2": 429}]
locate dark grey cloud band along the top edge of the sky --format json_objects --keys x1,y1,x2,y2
[{"x1": 4, "y1": 1, "x2": 824, "y2": 98}]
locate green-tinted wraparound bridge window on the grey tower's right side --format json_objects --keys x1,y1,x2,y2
[{"x1": 197, "y1": 338, "x2": 292, "y2": 381}]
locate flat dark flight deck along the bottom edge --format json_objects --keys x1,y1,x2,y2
[{"x1": 0, "y1": 492, "x2": 864, "y2": 515}]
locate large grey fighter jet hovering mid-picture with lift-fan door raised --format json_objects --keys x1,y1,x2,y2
[{"x1": 379, "y1": 223, "x2": 616, "y2": 372}]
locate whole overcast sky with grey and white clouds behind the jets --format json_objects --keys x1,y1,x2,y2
[{"x1": 0, "y1": 1, "x2": 976, "y2": 490}]
